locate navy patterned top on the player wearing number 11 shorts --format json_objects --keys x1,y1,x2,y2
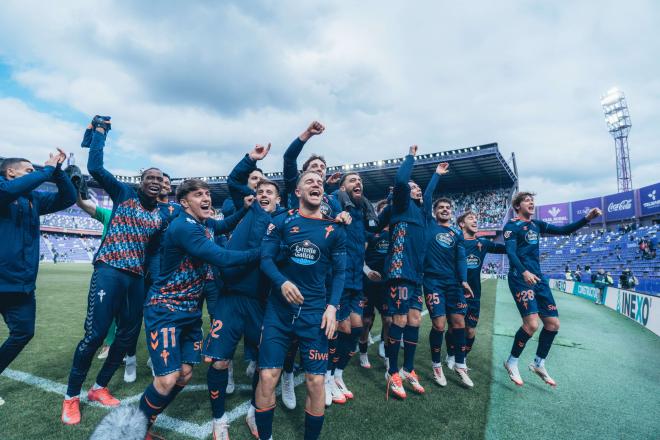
[{"x1": 147, "y1": 212, "x2": 259, "y2": 312}]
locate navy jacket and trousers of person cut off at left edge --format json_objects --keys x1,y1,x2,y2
[{"x1": 0, "y1": 165, "x2": 76, "y2": 373}]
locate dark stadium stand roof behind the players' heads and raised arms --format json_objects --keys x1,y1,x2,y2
[{"x1": 1, "y1": 143, "x2": 518, "y2": 205}]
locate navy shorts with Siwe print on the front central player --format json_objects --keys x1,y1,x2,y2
[{"x1": 259, "y1": 303, "x2": 328, "y2": 375}]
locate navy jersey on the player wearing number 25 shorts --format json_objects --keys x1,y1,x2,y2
[{"x1": 424, "y1": 222, "x2": 467, "y2": 284}]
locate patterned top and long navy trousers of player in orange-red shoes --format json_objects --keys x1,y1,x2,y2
[{"x1": 67, "y1": 130, "x2": 163, "y2": 397}]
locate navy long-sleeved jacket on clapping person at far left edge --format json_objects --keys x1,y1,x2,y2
[{"x1": 0, "y1": 162, "x2": 76, "y2": 293}]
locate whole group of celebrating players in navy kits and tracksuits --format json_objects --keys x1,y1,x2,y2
[{"x1": 0, "y1": 116, "x2": 600, "y2": 439}]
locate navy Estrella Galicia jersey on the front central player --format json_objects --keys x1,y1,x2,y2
[{"x1": 261, "y1": 209, "x2": 346, "y2": 313}]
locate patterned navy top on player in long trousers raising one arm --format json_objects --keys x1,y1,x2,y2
[{"x1": 87, "y1": 130, "x2": 163, "y2": 275}]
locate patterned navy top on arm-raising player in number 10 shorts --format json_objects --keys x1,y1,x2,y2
[{"x1": 385, "y1": 154, "x2": 431, "y2": 283}]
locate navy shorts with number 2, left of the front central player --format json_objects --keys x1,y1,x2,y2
[{"x1": 202, "y1": 295, "x2": 264, "y2": 361}]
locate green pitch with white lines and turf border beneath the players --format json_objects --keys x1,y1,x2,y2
[{"x1": 0, "y1": 264, "x2": 660, "y2": 440}]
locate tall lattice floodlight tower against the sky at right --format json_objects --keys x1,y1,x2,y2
[{"x1": 600, "y1": 87, "x2": 632, "y2": 192}]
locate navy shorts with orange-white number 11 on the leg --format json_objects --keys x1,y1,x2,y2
[{"x1": 144, "y1": 306, "x2": 204, "y2": 376}]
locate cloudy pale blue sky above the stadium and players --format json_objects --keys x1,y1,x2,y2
[{"x1": 0, "y1": 0, "x2": 660, "y2": 203}]
